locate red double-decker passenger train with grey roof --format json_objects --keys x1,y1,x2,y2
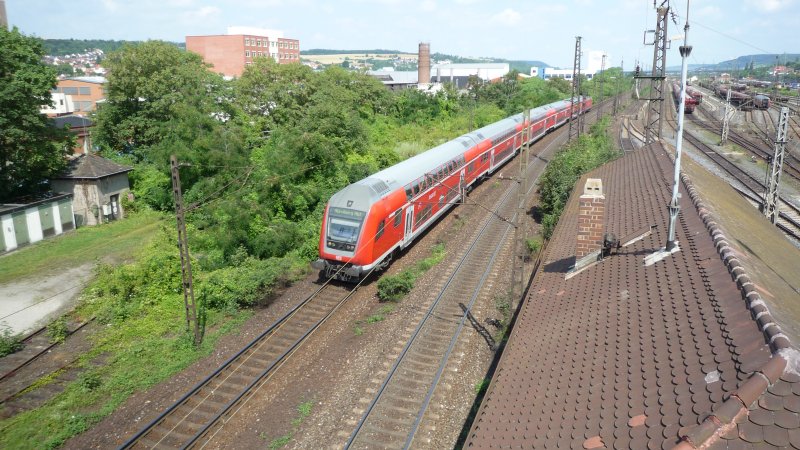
[{"x1": 312, "y1": 97, "x2": 592, "y2": 281}]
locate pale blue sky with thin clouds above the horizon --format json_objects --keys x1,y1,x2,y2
[{"x1": 6, "y1": 0, "x2": 800, "y2": 70}]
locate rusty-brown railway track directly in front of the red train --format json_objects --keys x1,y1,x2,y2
[{"x1": 120, "y1": 284, "x2": 366, "y2": 449}]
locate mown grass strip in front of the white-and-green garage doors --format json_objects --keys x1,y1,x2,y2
[{"x1": 0, "y1": 211, "x2": 165, "y2": 283}]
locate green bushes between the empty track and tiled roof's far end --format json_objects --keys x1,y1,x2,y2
[{"x1": 539, "y1": 117, "x2": 621, "y2": 239}]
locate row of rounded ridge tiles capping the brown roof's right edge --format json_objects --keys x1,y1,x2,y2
[{"x1": 667, "y1": 147, "x2": 800, "y2": 450}]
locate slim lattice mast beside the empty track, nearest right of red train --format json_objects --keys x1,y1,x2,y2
[{"x1": 511, "y1": 108, "x2": 532, "y2": 307}]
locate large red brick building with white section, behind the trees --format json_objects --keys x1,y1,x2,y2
[{"x1": 186, "y1": 27, "x2": 300, "y2": 77}]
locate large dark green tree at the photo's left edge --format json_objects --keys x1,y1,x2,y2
[{"x1": 0, "y1": 27, "x2": 71, "y2": 201}]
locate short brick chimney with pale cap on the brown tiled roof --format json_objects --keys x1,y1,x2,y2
[{"x1": 575, "y1": 178, "x2": 606, "y2": 261}]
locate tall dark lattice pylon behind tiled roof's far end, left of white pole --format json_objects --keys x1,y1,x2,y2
[{"x1": 640, "y1": 0, "x2": 669, "y2": 144}]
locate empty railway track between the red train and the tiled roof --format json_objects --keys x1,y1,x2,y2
[{"x1": 345, "y1": 132, "x2": 552, "y2": 449}]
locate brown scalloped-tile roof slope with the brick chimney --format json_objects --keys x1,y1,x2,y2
[{"x1": 467, "y1": 145, "x2": 800, "y2": 449}]
